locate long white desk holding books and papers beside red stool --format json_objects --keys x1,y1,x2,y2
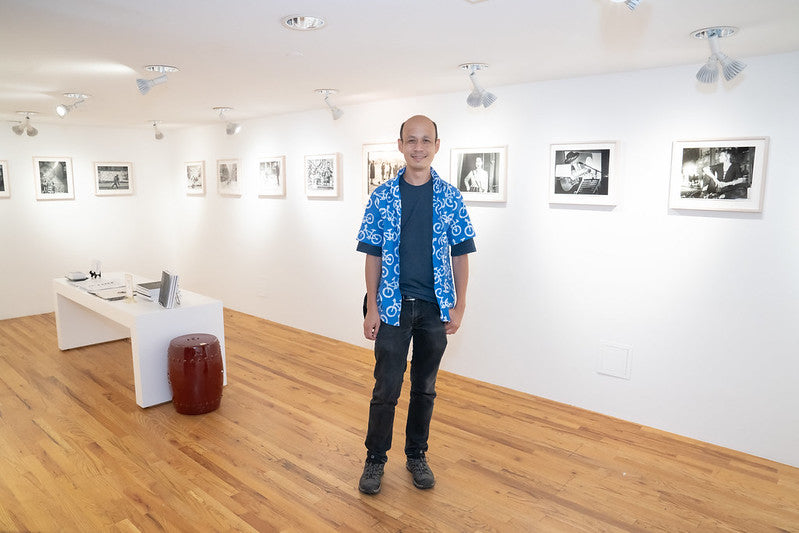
[{"x1": 53, "y1": 272, "x2": 227, "y2": 407}]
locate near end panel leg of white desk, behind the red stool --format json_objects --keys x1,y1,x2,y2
[{"x1": 130, "y1": 302, "x2": 227, "y2": 407}]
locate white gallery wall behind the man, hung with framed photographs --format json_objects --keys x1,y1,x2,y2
[{"x1": 0, "y1": 53, "x2": 799, "y2": 466}]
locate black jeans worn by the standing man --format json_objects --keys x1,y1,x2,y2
[{"x1": 366, "y1": 299, "x2": 447, "y2": 463}]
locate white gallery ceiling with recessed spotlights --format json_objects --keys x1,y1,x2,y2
[{"x1": 0, "y1": 0, "x2": 799, "y2": 130}]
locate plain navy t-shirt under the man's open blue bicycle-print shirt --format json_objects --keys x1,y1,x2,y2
[{"x1": 357, "y1": 178, "x2": 475, "y2": 303}]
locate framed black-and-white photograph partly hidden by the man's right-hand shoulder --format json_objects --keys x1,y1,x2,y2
[{"x1": 449, "y1": 146, "x2": 507, "y2": 202}]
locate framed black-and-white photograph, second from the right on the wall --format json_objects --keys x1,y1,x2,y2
[{"x1": 548, "y1": 141, "x2": 620, "y2": 205}]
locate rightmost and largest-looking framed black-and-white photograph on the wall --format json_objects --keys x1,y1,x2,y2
[{"x1": 669, "y1": 137, "x2": 768, "y2": 213}]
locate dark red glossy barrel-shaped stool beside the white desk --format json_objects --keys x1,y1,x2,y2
[{"x1": 168, "y1": 333, "x2": 224, "y2": 415}]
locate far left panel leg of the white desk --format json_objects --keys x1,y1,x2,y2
[{"x1": 55, "y1": 293, "x2": 130, "y2": 350}]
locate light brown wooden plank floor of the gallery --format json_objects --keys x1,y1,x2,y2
[{"x1": 0, "y1": 310, "x2": 799, "y2": 533}]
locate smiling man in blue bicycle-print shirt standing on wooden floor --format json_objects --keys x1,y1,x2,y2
[{"x1": 357, "y1": 115, "x2": 475, "y2": 494}]
